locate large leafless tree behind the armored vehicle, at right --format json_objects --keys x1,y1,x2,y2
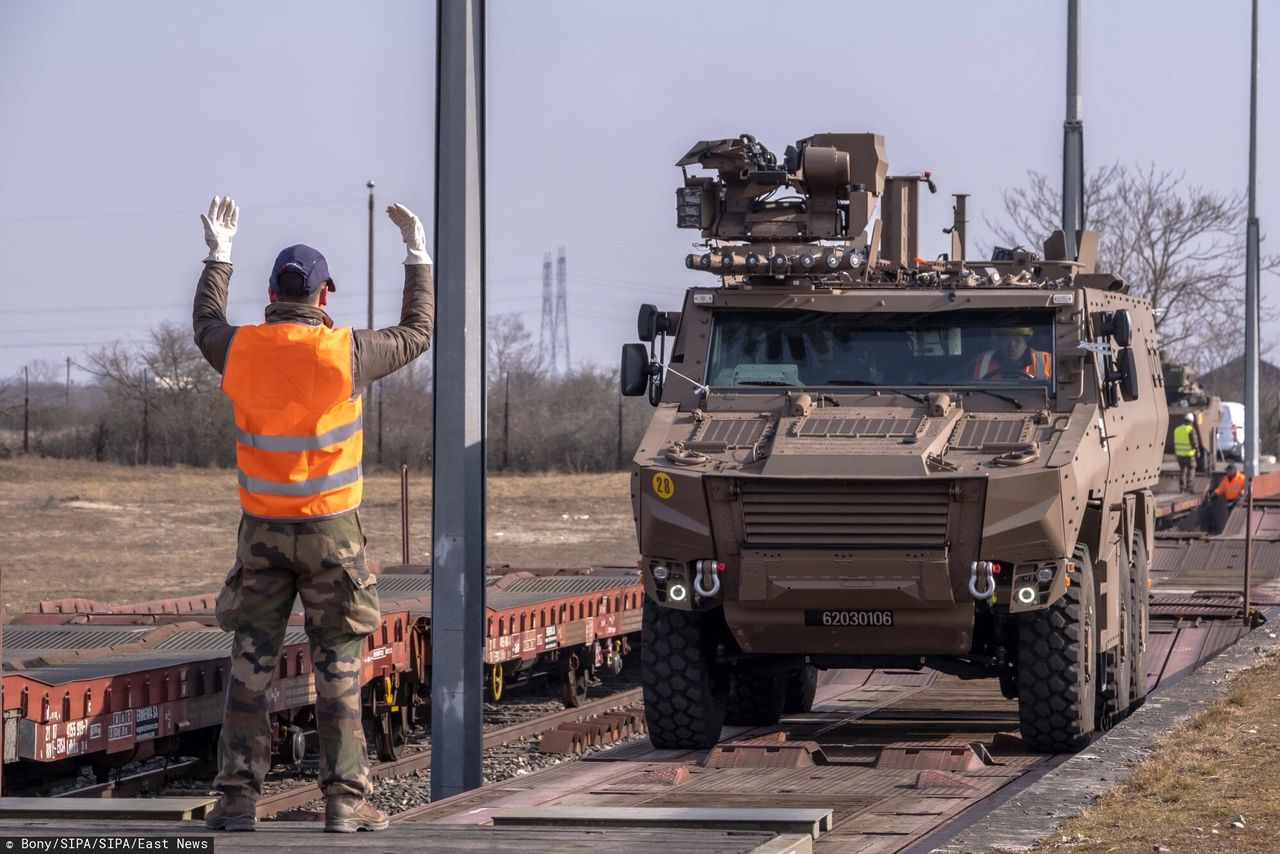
[{"x1": 988, "y1": 163, "x2": 1280, "y2": 371}]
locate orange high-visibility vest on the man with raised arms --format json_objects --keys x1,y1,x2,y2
[{"x1": 223, "y1": 323, "x2": 364, "y2": 521}]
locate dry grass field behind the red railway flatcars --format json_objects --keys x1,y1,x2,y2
[{"x1": 0, "y1": 457, "x2": 637, "y2": 612}]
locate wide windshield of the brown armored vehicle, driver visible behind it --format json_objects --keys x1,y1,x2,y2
[{"x1": 707, "y1": 310, "x2": 1053, "y2": 393}]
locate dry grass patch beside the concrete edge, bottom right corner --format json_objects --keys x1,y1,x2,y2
[{"x1": 1036, "y1": 659, "x2": 1280, "y2": 854}]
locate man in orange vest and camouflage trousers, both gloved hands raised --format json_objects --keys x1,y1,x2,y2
[{"x1": 192, "y1": 197, "x2": 435, "y2": 832}]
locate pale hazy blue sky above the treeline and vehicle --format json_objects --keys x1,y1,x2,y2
[{"x1": 0, "y1": 0, "x2": 1280, "y2": 376}]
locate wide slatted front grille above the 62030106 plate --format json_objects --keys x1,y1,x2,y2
[{"x1": 740, "y1": 479, "x2": 950, "y2": 548}]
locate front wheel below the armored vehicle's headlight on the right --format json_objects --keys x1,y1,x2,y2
[{"x1": 1018, "y1": 547, "x2": 1097, "y2": 753}]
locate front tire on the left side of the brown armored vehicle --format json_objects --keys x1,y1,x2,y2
[{"x1": 640, "y1": 597, "x2": 728, "y2": 750}]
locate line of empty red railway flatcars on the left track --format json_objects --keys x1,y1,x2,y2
[{"x1": 3, "y1": 566, "x2": 643, "y2": 785}]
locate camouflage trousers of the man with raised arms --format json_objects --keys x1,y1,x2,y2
[{"x1": 214, "y1": 512, "x2": 380, "y2": 799}]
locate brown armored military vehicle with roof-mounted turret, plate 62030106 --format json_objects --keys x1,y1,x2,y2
[{"x1": 621, "y1": 133, "x2": 1167, "y2": 752}]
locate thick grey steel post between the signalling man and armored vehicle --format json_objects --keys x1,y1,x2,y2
[{"x1": 431, "y1": 0, "x2": 485, "y2": 802}]
